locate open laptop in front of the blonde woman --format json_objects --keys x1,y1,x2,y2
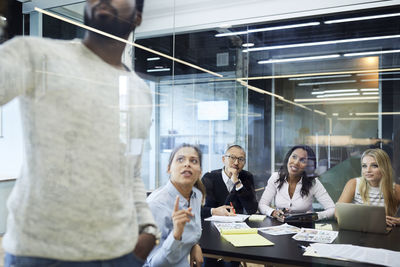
[{"x1": 336, "y1": 203, "x2": 392, "y2": 234}]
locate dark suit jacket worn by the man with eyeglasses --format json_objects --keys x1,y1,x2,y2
[{"x1": 201, "y1": 169, "x2": 258, "y2": 218}]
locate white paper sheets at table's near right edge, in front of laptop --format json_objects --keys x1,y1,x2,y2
[{"x1": 303, "y1": 243, "x2": 400, "y2": 267}]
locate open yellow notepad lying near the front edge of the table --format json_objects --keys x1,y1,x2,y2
[{"x1": 221, "y1": 228, "x2": 274, "y2": 247}]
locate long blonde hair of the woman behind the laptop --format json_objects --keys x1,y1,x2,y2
[{"x1": 359, "y1": 148, "x2": 398, "y2": 216}]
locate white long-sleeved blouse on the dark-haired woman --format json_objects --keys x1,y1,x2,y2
[{"x1": 258, "y1": 172, "x2": 335, "y2": 220}]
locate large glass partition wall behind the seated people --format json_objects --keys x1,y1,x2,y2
[{"x1": 32, "y1": 3, "x2": 400, "y2": 200}]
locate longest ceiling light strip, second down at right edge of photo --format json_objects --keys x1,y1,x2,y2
[{"x1": 243, "y1": 34, "x2": 400, "y2": 52}]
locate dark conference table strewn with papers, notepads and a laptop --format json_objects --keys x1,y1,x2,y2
[{"x1": 200, "y1": 217, "x2": 400, "y2": 267}]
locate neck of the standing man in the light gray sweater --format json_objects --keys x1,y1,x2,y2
[{"x1": 83, "y1": 32, "x2": 128, "y2": 70}]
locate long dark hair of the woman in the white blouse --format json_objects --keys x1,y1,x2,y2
[{"x1": 276, "y1": 145, "x2": 317, "y2": 197}]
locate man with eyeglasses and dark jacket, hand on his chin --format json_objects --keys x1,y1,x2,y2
[{"x1": 202, "y1": 145, "x2": 257, "y2": 218}]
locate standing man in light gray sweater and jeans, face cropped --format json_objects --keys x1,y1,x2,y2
[{"x1": 0, "y1": 0, "x2": 157, "y2": 267}]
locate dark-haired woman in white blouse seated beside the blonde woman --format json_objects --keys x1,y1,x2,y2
[{"x1": 258, "y1": 145, "x2": 335, "y2": 220}]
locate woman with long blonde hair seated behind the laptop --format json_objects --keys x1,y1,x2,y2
[{"x1": 338, "y1": 149, "x2": 400, "y2": 226}]
